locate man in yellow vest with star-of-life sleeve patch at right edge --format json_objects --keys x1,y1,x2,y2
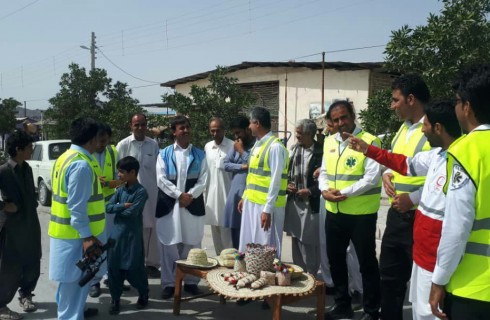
[{"x1": 429, "y1": 65, "x2": 490, "y2": 320}]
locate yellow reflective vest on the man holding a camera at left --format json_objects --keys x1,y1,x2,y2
[{"x1": 48, "y1": 149, "x2": 105, "y2": 239}]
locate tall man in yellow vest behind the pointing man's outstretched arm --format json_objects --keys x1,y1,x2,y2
[{"x1": 379, "y1": 74, "x2": 430, "y2": 320}]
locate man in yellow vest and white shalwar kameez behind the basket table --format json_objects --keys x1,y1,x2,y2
[{"x1": 238, "y1": 107, "x2": 289, "y2": 258}]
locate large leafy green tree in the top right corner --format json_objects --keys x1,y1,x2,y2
[{"x1": 385, "y1": 0, "x2": 490, "y2": 98}]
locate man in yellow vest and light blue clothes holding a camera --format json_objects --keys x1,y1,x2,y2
[{"x1": 48, "y1": 118, "x2": 105, "y2": 319}]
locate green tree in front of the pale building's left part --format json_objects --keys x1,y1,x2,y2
[{"x1": 162, "y1": 66, "x2": 255, "y2": 148}]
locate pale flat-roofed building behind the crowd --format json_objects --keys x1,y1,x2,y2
[{"x1": 161, "y1": 62, "x2": 393, "y2": 148}]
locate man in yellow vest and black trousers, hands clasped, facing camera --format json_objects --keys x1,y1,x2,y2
[{"x1": 319, "y1": 101, "x2": 381, "y2": 320}]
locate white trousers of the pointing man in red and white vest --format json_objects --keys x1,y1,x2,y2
[{"x1": 408, "y1": 262, "x2": 437, "y2": 320}]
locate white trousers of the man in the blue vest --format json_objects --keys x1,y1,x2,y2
[{"x1": 160, "y1": 243, "x2": 201, "y2": 289}]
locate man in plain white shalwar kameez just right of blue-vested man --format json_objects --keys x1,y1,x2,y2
[{"x1": 204, "y1": 118, "x2": 233, "y2": 255}]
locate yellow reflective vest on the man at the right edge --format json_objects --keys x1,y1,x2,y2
[{"x1": 446, "y1": 130, "x2": 490, "y2": 302}]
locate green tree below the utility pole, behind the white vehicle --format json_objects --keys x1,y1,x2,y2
[{"x1": 45, "y1": 64, "x2": 143, "y2": 142}]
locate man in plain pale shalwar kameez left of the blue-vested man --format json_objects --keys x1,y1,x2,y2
[{"x1": 116, "y1": 114, "x2": 160, "y2": 278}]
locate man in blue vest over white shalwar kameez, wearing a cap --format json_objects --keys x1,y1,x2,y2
[{"x1": 156, "y1": 116, "x2": 207, "y2": 299}]
